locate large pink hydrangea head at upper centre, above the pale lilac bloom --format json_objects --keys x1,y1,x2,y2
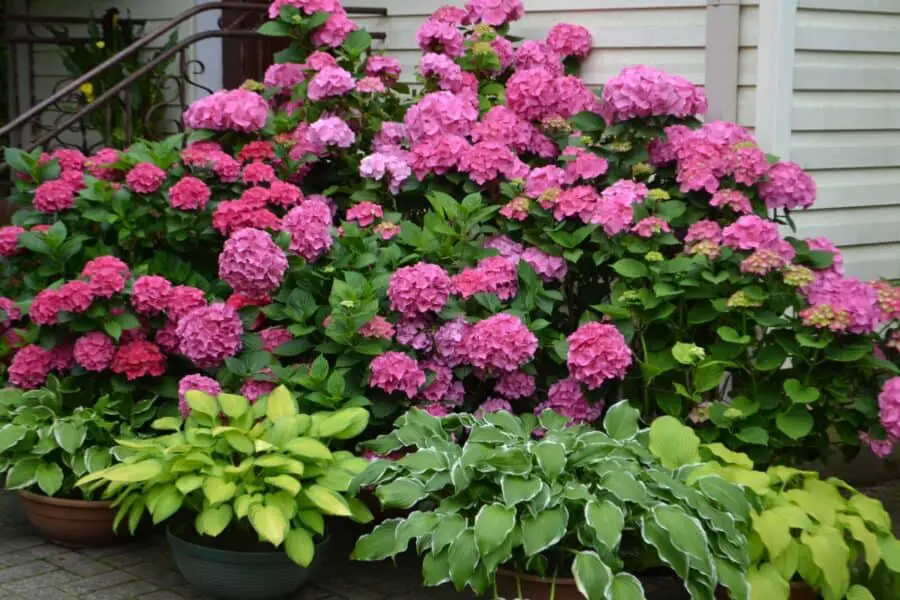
[{"x1": 403, "y1": 92, "x2": 478, "y2": 144}]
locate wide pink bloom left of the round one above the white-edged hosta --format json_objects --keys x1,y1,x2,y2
[{"x1": 465, "y1": 313, "x2": 537, "y2": 371}]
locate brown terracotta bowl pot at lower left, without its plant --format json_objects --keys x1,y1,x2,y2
[{"x1": 19, "y1": 491, "x2": 126, "y2": 548}]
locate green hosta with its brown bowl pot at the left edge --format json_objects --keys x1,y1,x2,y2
[{"x1": 0, "y1": 377, "x2": 122, "y2": 548}]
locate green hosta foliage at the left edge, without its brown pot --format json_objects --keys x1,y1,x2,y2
[{"x1": 0, "y1": 377, "x2": 119, "y2": 499}]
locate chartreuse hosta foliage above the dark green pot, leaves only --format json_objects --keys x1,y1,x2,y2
[{"x1": 78, "y1": 386, "x2": 372, "y2": 566}]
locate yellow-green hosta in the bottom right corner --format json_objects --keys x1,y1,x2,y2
[{"x1": 691, "y1": 442, "x2": 900, "y2": 600}]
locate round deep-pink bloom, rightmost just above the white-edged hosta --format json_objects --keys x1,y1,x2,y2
[{"x1": 567, "y1": 323, "x2": 632, "y2": 389}]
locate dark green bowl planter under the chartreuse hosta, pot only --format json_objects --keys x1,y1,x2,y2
[{"x1": 166, "y1": 527, "x2": 330, "y2": 600}]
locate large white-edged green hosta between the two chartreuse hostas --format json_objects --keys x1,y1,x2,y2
[{"x1": 353, "y1": 402, "x2": 751, "y2": 600}]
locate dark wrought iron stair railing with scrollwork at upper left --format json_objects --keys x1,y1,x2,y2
[{"x1": 0, "y1": 2, "x2": 387, "y2": 173}]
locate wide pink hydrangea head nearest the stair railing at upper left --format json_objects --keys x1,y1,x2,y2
[{"x1": 184, "y1": 88, "x2": 269, "y2": 133}]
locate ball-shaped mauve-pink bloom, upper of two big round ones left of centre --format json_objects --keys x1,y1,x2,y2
[{"x1": 219, "y1": 228, "x2": 287, "y2": 298}]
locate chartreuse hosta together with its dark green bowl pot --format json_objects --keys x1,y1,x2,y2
[{"x1": 78, "y1": 386, "x2": 372, "y2": 600}]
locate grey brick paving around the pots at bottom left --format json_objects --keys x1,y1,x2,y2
[{"x1": 0, "y1": 492, "x2": 471, "y2": 600}]
